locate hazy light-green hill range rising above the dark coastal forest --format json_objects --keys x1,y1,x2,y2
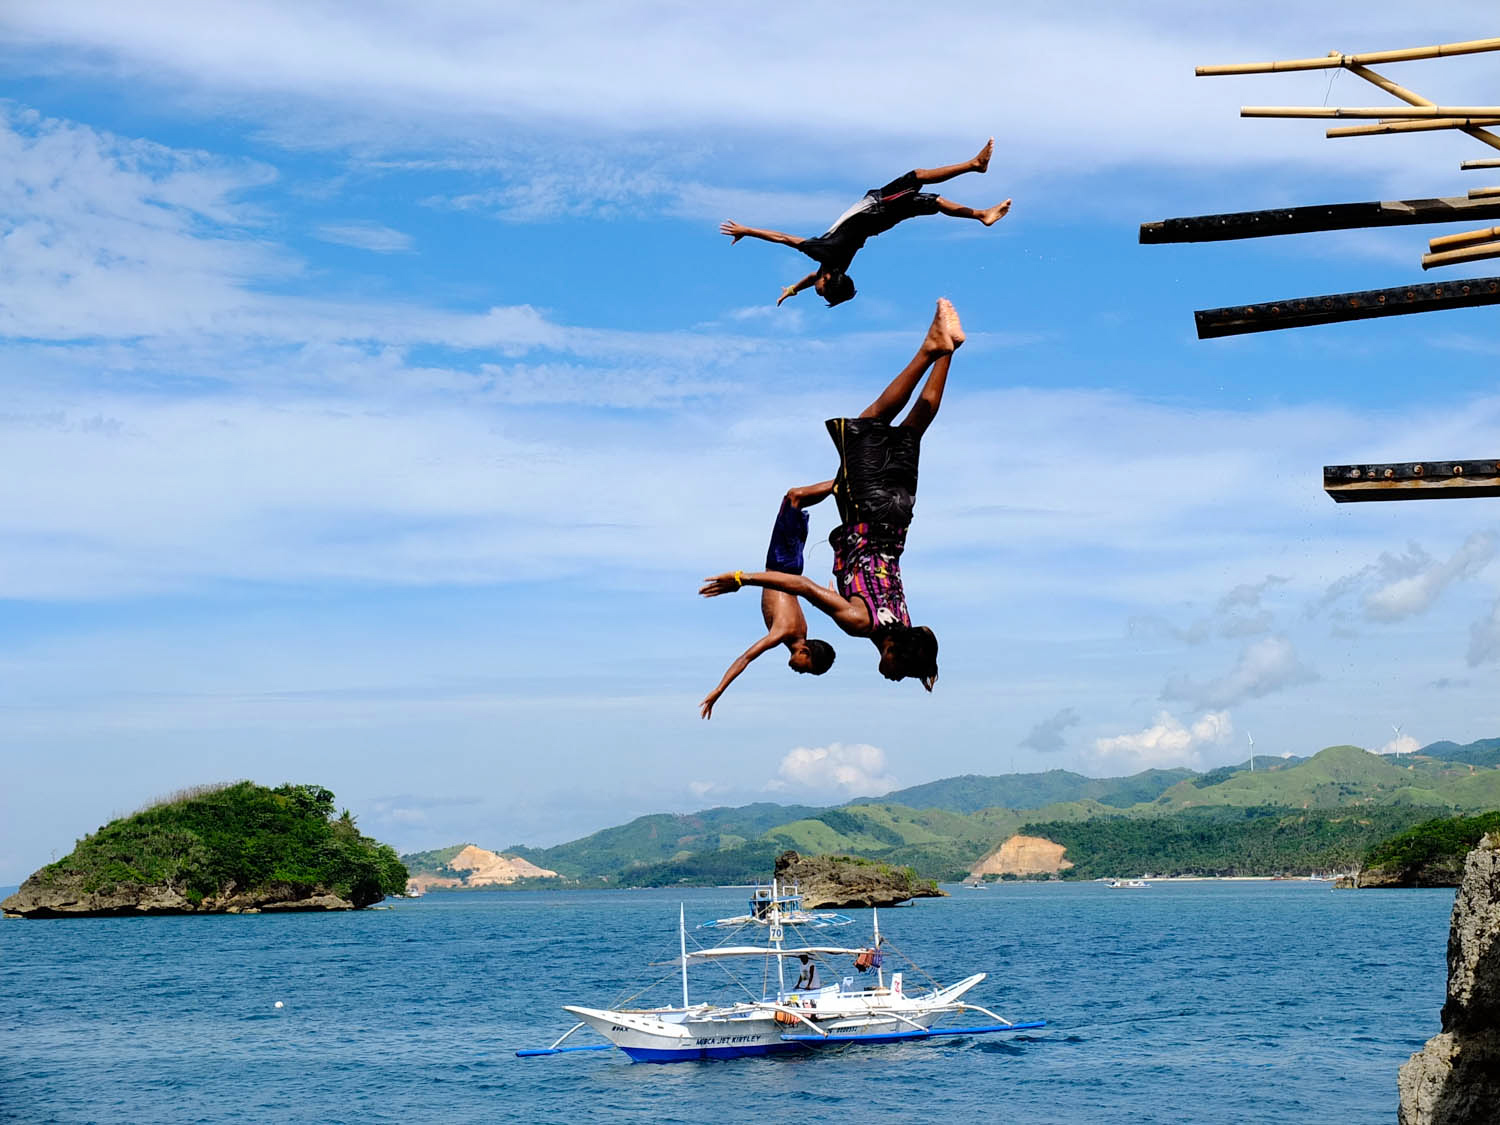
[{"x1": 405, "y1": 738, "x2": 1500, "y2": 887}]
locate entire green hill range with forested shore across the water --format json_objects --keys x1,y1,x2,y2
[{"x1": 405, "y1": 740, "x2": 1500, "y2": 887}]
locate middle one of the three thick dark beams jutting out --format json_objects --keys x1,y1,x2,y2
[{"x1": 1193, "y1": 278, "x2": 1500, "y2": 341}]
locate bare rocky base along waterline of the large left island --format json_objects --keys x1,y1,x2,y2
[{"x1": 0, "y1": 872, "x2": 363, "y2": 918}]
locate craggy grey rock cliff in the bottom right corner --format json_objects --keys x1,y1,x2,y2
[{"x1": 1398, "y1": 833, "x2": 1500, "y2": 1125}]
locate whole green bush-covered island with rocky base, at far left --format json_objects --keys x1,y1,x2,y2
[{"x1": 0, "y1": 782, "x2": 407, "y2": 918}]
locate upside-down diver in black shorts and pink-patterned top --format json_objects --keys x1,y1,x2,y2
[{"x1": 698, "y1": 297, "x2": 965, "y2": 692}]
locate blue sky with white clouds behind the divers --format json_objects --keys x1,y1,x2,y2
[{"x1": 0, "y1": 0, "x2": 1500, "y2": 882}]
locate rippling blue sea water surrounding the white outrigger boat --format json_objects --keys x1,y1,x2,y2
[{"x1": 0, "y1": 882, "x2": 1454, "y2": 1125}]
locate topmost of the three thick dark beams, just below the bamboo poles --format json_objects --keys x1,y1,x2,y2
[{"x1": 1140, "y1": 195, "x2": 1500, "y2": 245}]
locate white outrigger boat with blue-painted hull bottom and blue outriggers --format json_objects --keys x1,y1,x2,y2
[{"x1": 516, "y1": 890, "x2": 1046, "y2": 1062}]
